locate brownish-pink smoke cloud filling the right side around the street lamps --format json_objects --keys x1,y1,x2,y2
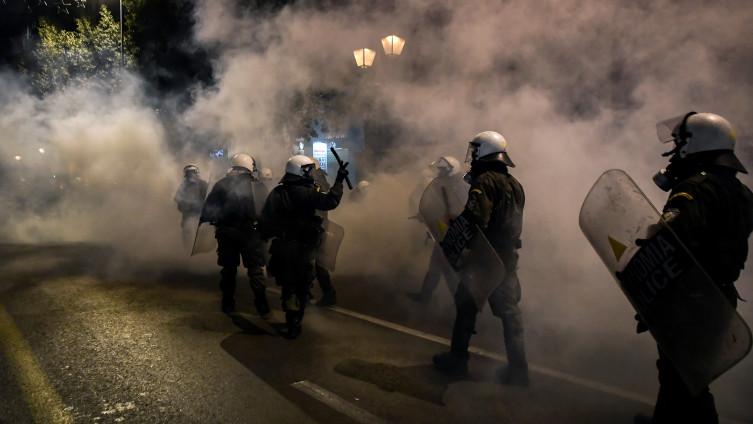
[{"x1": 191, "y1": 0, "x2": 753, "y2": 408}]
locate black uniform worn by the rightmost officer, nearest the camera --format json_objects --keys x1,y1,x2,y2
[{"x1": 653, "y1": 165, "x2": 753, "y2": 423}]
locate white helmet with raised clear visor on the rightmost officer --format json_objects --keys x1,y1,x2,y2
[{"x1": 656, "y1": 112, "x2": 747, "y2": 173}]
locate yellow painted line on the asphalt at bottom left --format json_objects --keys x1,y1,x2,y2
[{"x1": 0, "y1": 305, "x2": 73, "y2": 424}]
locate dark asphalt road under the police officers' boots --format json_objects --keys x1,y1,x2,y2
[{"x1": 0, "y1": 244, "x2": 753, "y2": 423}]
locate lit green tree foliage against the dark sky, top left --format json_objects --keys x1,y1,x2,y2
[{"x1": 32, "y1": 6, "x2": 135, "y2": 93}]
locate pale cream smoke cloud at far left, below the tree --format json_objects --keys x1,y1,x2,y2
[{"x1": 0, "y1": 75, "x2": 188, "y2": 260}]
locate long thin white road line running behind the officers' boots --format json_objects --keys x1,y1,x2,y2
[{"x1": 267, "y1": 288, "x2": 744, "y2": 424}]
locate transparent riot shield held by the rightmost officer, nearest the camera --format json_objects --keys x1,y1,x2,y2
[{"x1": 579, "y1": 170, "x2": 751, "y2": 393}]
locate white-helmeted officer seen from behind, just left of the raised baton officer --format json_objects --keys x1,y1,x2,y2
[{"x1": 201, "y1": 153, "x2": 269, "y2": 317}]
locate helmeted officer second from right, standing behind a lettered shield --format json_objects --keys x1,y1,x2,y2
[{"x1": 434, "y1": 131, "x2": 528, "y2": 386}]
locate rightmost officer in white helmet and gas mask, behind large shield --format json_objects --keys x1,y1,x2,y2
[{"x1": 636, "y1": 112, "x2": 753, "y2": 424}]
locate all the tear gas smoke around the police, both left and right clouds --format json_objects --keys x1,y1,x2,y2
[{"x1": 0, "y1": 0, "x2": 753, "y2": 415}]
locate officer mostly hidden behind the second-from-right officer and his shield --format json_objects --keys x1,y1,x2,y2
[{"x1": 408, "y1": 156, "x2": 470, "y2": 303}]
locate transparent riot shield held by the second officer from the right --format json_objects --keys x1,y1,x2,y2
[{"x1": 418, "y1": 178, "x2": 506, "y2": 311}]
